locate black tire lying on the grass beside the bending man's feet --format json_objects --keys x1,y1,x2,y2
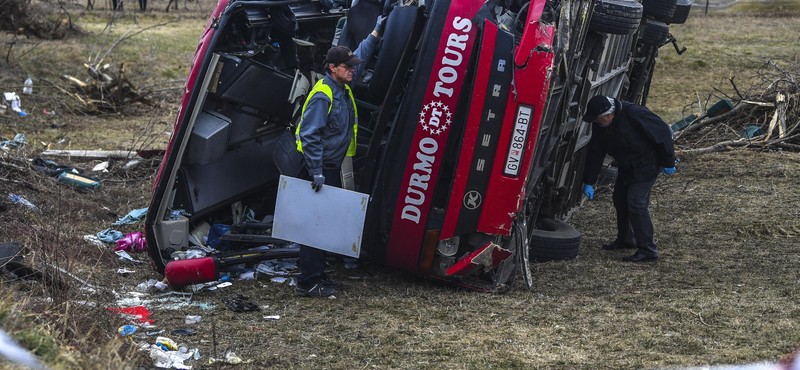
[{"x1": 530, "y1": 218, "x2": 581, "y2": 262}]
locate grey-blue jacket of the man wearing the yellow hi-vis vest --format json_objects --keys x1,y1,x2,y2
[{"x1": 296, "y1": 35, "x2": 378, "y2": 178}]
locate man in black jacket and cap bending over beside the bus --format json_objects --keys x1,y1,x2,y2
[{"x1": 583, "y1": 96, "x2": 675, "y2": 262}]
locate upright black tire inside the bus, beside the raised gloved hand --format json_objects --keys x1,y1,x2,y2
[{"x1": 369, "y1": 6, "x2": 417, "y2": 99}]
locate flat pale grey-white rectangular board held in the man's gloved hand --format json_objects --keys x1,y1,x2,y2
[{"x1": 272, "y1": 175, "x2": 369, "y2": 258}]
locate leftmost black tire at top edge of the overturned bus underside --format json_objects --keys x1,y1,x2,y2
[{"x1": 589, "y1": 0, "x2": 643, "y2": 35}]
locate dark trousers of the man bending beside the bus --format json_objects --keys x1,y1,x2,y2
[{"x1": 613, "y1": 174, "x2": 658, "y2": 256}]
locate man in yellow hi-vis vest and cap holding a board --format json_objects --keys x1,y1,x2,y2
[{"x1": 295, "y1": 16, "x2": 386, "y2": 297}]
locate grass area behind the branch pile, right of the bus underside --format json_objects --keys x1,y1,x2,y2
[{"x1": 647, "y1": 12, "x2": 800, "y2": 123}]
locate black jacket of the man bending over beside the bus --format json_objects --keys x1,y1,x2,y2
[{"x1": 583, "y1": 100, "x2": 675, "y2": 185}]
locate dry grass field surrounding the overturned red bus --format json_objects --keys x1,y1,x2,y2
[{"x1": 0, "y1": 2, "x2": 800, "y2": 369}]
